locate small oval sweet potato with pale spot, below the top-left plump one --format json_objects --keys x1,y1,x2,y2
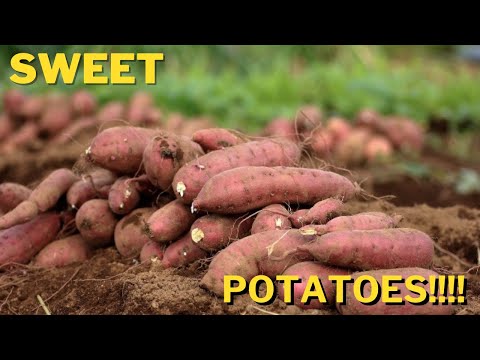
[{"x1": 108, "y1": 176, "x2": 140, "y2": 215}]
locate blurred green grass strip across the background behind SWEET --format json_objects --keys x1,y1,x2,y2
[{"x1": 0, "y1": 45, "x2": 480, "y2": 130}]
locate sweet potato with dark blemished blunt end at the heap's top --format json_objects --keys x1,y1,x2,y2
[{"x1": 143, "y1": 131, "x2": 204, "y2": 190}]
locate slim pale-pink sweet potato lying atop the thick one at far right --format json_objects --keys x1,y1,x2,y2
[{"x1": 300, "y1": 212, "x2": 402, "y2": 235}]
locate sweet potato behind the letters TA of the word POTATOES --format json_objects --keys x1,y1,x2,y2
[{"x1": 277, "y1": 261, "x2": 350, "y2": 309}]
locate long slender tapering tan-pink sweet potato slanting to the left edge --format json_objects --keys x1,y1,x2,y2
[{"x1": 0, "y1": 168, "x2": 78, "y2": 230}]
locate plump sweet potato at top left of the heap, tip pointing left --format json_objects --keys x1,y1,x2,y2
[{"x1": 85, "y1": 126, "x2": 157, "y2": 174}]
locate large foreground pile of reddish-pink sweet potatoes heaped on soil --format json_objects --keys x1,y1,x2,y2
[{"x1": 0, "y1": 94, "x2": 446, "y2": 314}]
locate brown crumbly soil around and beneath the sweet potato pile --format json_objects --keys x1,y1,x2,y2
[{"x1": 0, "y1": 141, "x2": 480, "y2": 315}]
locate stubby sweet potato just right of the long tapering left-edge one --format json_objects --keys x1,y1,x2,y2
[{"x1": 67, "y1": 168, "x2": 117, "y2": 209}]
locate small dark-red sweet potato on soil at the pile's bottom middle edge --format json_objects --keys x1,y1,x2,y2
[{"x1": 162, "y1": 233, "x2": 208, "y2": 268}]
